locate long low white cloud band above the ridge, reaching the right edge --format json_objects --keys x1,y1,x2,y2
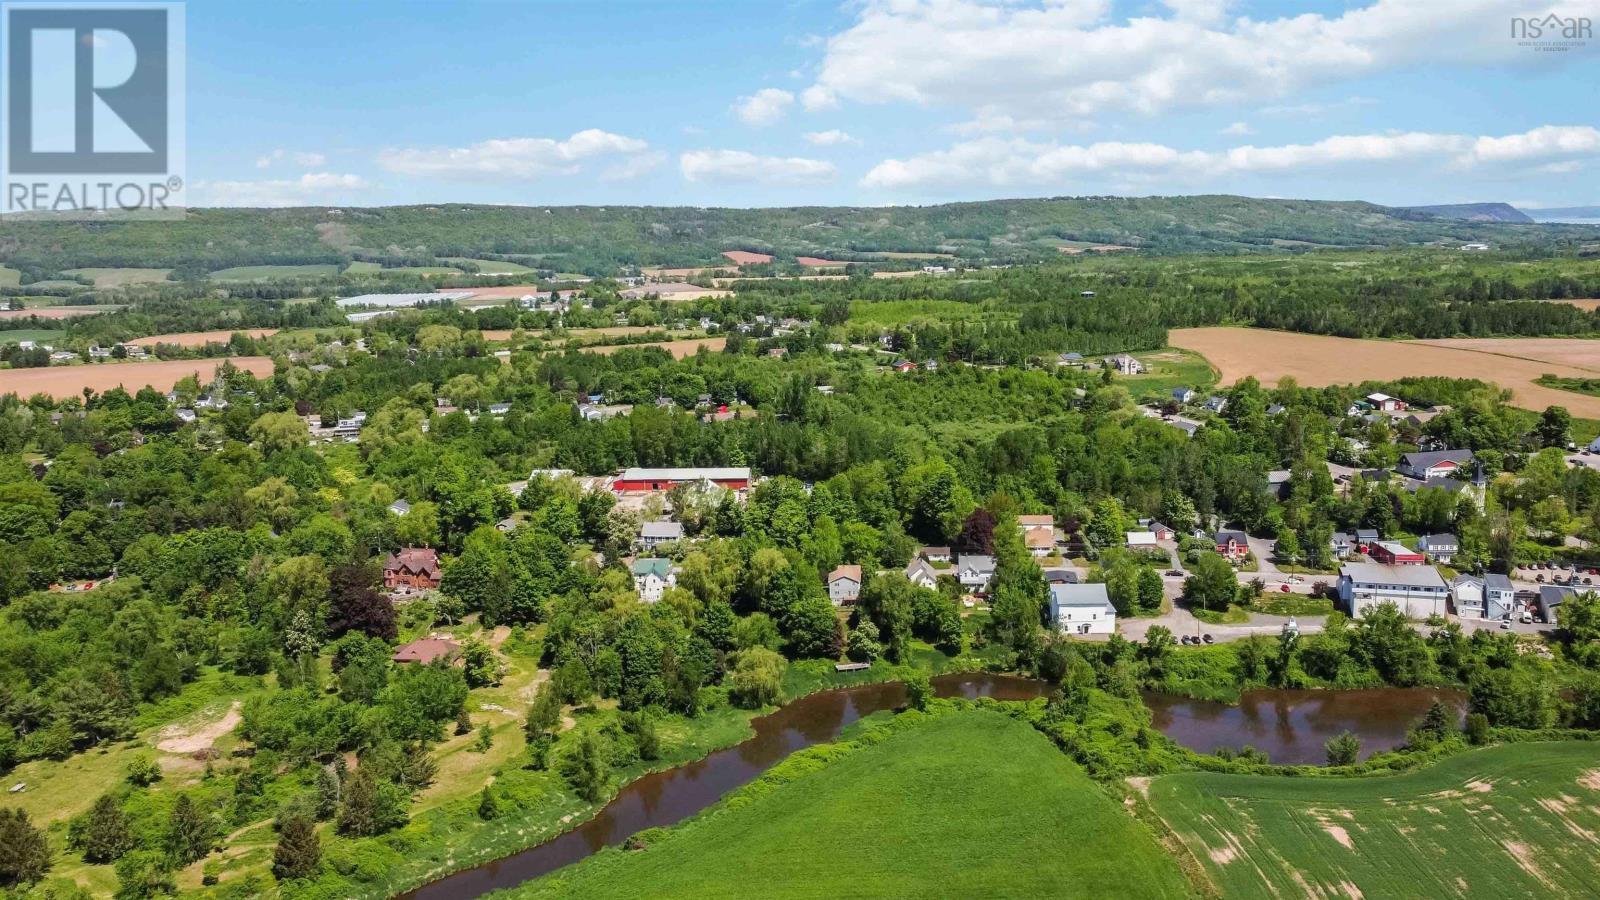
[{"x1": 861, "y1": 125, "x2": 1600, "y2": 189}]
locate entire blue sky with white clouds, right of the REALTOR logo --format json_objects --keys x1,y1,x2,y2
[{"x1": 187, "y1": 0, "x2": 1600, "y2": 207}]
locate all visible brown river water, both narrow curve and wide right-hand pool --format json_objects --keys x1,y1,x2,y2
[{"x1": 400, "y1": 673, "x2": 1466, "y2": 900}]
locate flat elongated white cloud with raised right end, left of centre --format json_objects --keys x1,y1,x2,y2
[{"x1": 378, "y1": 128, "x2": 650, "y2": 181}]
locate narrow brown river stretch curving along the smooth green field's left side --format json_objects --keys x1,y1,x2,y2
[{"x1": 400, "y1": 673, "x2": 1048, "y2": 900}]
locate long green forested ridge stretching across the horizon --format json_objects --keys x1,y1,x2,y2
[{"x1": 0, "y1": 195, "x2": 1600, "y2": 279}]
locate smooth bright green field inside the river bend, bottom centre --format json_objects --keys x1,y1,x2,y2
[{"x1": 517, "y1": 709, "x2": 1189, "y2": 900}]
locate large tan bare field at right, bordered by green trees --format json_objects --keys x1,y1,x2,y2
[{"x1": 1166, "y1": 328, "x2": 1600, "y2": 418}]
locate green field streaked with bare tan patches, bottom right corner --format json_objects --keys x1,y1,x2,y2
[{"x1": 1149, "y1": 741, "x2": 1600, "y2": 900}]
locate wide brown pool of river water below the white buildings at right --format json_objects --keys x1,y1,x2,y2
[{"x1": 1144, "y1": 687, "x2": 1467, "y2": 765}]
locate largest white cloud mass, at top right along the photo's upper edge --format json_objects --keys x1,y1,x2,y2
[{"x1": 802, "y1": 0, "x2": 1595, "y2": 123}]
